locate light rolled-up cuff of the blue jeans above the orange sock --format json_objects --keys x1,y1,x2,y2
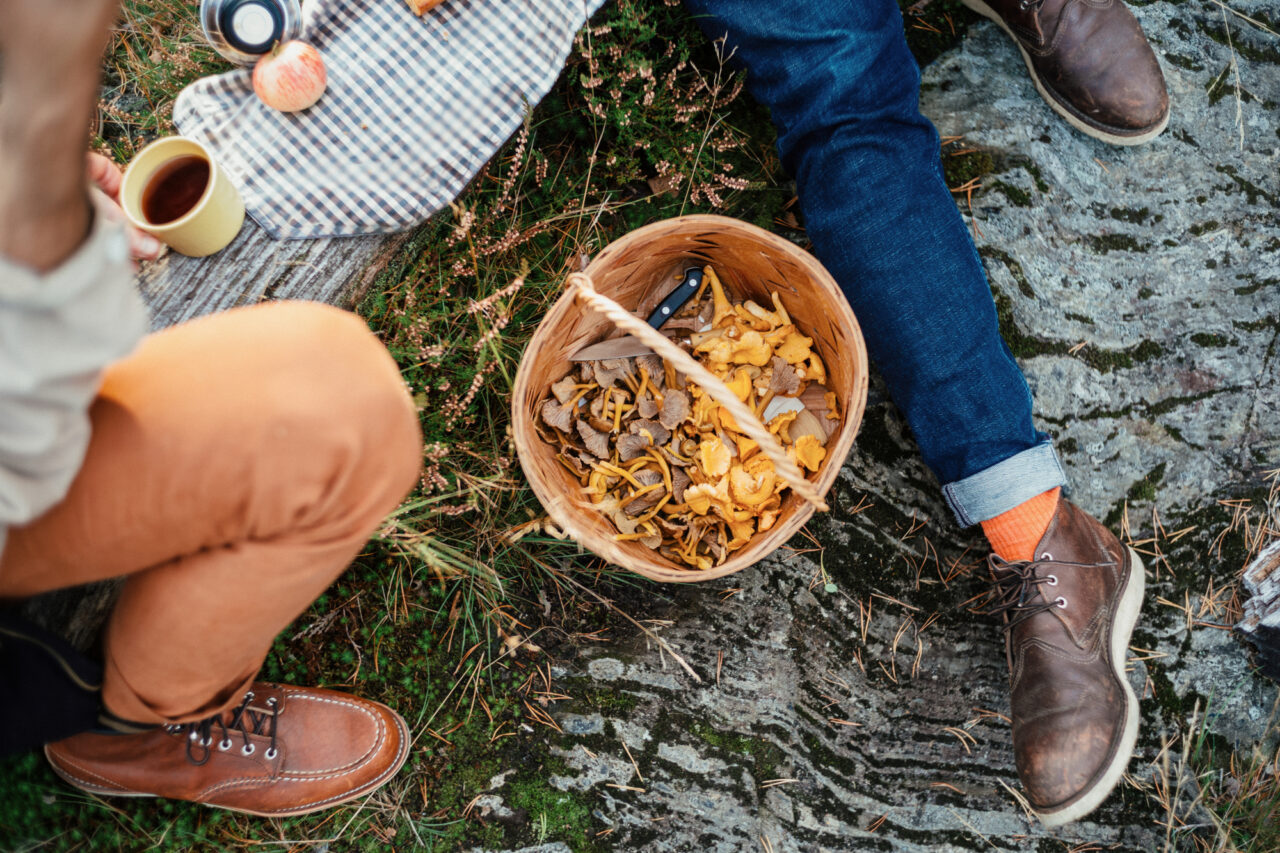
[{"x1": 942, "y1": 442, "x2": 1066, "y2": 528}]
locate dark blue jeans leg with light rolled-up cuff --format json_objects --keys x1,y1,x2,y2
[{"x1": 685, "y1": 0, "x2": 1065, "y2": 526}]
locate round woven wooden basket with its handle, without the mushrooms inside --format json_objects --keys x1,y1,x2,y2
[{"x1": 511, "y1": 215, "x2": 868, "y2": 583}]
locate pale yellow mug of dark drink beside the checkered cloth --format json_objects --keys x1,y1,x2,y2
[{"x1": 120, "y1": 136, "x2": 244, "y2": 257}]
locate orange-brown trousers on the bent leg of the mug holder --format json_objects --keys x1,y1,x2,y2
[{"x1": 0, "y1": 302, "x2": 421, "y2": 724}]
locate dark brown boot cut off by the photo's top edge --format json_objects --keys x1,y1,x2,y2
[{"x1": 963, "y1": 0, "x2": 1169, "y2": 145}]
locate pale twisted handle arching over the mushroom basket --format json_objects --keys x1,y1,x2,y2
[{"x1": 567, "y1": 273, "x2": 828, "y2": 512}]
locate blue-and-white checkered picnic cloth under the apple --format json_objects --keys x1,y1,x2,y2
[{"x1": 174, "y1": 0, "x2": 604, "y2": 240}]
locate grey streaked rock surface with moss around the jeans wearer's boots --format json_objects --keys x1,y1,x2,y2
[{"x1": 476, "y1": 0, "x2": 1280, "y2": 852}]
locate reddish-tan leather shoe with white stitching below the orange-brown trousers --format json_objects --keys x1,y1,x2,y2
[{"x1": 45, "y1": 681, "x2": 410, "y2": 817}]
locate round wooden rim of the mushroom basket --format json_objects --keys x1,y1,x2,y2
[{"x1": 511, "y1": 214, "x2": 869, "y2": 583}]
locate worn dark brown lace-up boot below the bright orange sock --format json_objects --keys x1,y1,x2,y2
[{"x1": 987, "y1": 500, "x2": 1144, "y2": 826}]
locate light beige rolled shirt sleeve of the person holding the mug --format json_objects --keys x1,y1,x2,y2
[{"x1": 0, "y1": 216, "x2": 147, "y2": 552}]
